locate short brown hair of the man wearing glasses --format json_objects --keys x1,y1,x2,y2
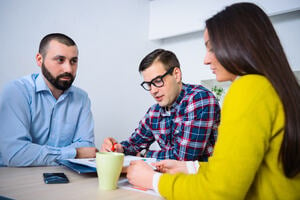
[{"x1": 139, "y1": 49, "x2": 180, "y2": 72}]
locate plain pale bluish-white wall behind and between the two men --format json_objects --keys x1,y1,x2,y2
[{"x1": 0, "y1": 0, "x2": 157, "y2": 147}]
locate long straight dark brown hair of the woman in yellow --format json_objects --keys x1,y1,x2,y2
[{"x1": 206, "y1": 3, "x2": 300, "y2": 178}]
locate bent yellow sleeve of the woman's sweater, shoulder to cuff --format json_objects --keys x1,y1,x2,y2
[{"x1": 159, "y1": 75, "x2": 274, "y2": 199}]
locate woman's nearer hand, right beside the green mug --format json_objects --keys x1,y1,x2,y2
[{"x1": 127, "y1": 160, "x2": 154, "y2": 189}]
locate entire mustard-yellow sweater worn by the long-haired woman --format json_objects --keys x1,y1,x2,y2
[{"x1": 158, "y1": 75, "x2": 300, "y2": 200}]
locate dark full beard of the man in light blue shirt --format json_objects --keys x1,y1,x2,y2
[{"x1": 42, "y1": 62, "x2": 74, "y2": 91}]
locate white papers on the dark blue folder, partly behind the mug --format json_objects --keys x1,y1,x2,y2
[{"x1": 67, "y1": 156, "x2": 156, "y2": 168}]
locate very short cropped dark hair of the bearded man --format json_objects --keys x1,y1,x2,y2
[{"x1": 39, "y1": 33, "x2": 76, "y2": 57}]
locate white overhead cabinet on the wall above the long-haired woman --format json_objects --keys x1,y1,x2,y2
[{"x1": 149, "y1": 0, "x2": 300, "y2": 39}]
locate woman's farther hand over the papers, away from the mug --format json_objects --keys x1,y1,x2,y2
[{"x1": 153, "y1": 160, "x2": 188, "y2": 174}]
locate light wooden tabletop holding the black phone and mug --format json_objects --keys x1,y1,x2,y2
[{"x1": 0, "y1": 166, "x2": 162, "y2": 200}]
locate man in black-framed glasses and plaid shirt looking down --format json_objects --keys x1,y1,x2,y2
[{"x1": 101, "y1": 49, "x2": 220, "y2": 161}]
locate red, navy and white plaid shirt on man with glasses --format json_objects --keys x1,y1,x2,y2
[{"x1": 121, "y1": 84, "x2": 220, "y2": 161}]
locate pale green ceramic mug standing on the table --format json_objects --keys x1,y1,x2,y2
[{"x1": 96, "y1": 152, "x2": 124, "y2": 190}]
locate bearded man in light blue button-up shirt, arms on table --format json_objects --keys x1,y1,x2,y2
[{"x1": 0, "y1": 33, "x2": 97, "y2": 166}]
